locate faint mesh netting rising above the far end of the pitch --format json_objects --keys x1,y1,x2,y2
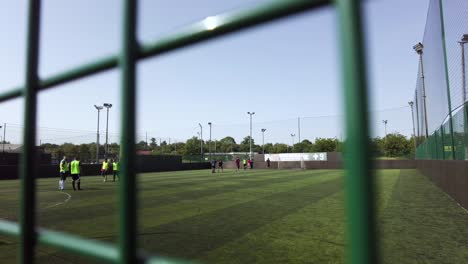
[{"x1": 2, "y1": 105, "x2": 412, "y2": 153}]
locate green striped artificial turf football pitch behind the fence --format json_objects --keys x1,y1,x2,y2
[{"x1": 0, "y1": 170, "x2": 468, "y2": 263}]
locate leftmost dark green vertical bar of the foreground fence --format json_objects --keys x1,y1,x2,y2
[{"x1": 19, "y1": 0, "x2": 41, "y2": 264}]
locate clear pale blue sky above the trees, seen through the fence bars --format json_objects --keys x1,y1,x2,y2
[{"x1": 0, "y1": 0, "x2": 428, "y2": 143}]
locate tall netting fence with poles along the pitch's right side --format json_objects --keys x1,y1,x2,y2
[{"x1": 413, "y1": 0, "x2": 468, "y2": 160}]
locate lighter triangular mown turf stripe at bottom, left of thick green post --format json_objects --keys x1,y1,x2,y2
[{"x1": 200, "y1": 191, "x2": 346, "y2": 263}]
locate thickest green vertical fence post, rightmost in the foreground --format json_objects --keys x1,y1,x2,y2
[{"x1": 337, "y1": 0, "x2": 378, "y2": 264}]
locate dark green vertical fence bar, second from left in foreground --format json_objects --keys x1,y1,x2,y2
[{"x1": 119, "y1": 0, "x2": 138, "y2": 263}]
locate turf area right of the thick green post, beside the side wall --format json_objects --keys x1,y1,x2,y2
[{"x1": 379, "y1": 170, "x2": 468, "y2": 263}]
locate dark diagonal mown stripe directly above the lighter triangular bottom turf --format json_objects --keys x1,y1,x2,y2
[{"x1": 135, "y1": 175, "x2": 343, "y2": 259}]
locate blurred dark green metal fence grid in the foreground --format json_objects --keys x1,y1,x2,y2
[{"x1": 0, "y1": 0, "x2": 378, "y2": 264}]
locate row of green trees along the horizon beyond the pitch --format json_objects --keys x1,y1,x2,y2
[{"x1": 40, "y1": 133, "x2": 414, "y2": 161}]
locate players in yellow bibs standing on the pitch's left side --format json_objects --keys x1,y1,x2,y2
[{"x1": 59, "y1": 156, "x2": 119, "y2": 191}]
